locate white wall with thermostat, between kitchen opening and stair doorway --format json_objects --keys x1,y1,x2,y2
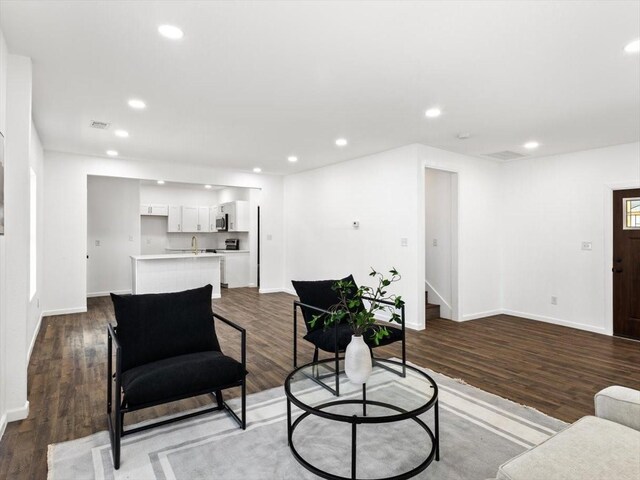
[{"x1": 284, "y1": 145, "x2": 424, "y2": 328}]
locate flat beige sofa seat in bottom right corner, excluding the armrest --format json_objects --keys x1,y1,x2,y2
[{"x1": 497, "y1": 416, "x2": 640, "y2": 480}]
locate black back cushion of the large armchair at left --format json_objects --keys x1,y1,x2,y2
[{"x1": 111, "y1": 285, "x2": 220, "y2": 371}]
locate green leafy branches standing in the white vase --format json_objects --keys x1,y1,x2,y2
[{"x1": 310, "y1": 268, "x2": 404, "y2": 345}]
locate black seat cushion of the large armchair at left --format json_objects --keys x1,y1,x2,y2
[{"x1": 122, "y1": 351, "x2": 244, "y2": 407}]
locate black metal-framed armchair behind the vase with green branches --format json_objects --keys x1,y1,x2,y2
[{"x1": 291, "y1": 275, "x2": 407, "y2": 396}]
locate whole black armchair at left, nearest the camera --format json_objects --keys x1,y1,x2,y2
[{"x1": 107, "y1": 285, "x2": 247, "y2": 469}]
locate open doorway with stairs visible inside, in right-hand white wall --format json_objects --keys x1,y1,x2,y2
[{"x1": 424, "y1": 168, "x2": 458, "y2": 323}]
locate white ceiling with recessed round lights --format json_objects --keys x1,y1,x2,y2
[{"x1": 0, "y1": 0, "x2": 640, "y2": 174}]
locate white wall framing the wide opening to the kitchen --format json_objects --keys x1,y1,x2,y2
[{"x1": 42, "y1": 151, "x2": 284, "y2": 315}]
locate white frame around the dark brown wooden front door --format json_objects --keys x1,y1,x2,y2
[{"x1": 602, "y1": 181, "x2": 640, "y2": 338}]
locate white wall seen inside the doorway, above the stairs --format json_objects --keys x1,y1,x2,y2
[{"x1": 425, "y1": 168, "x2": 456, "y2": 318}]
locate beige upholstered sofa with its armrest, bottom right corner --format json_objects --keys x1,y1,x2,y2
[{"x1": 497, "y1": 387, "x2": 640, "y2": 480}]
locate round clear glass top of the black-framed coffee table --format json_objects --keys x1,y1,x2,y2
[{"x1": 285, "y1": 359, "x2": 438, "y2": 423}]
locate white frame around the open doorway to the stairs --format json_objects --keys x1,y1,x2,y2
[{"x1": 418, "y1": 161, "x2": 462, "y2": 325}]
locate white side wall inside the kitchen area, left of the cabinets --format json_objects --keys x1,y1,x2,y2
[{"x1": 87, "y1": 176, "x2": 140, "y2": 296}]
